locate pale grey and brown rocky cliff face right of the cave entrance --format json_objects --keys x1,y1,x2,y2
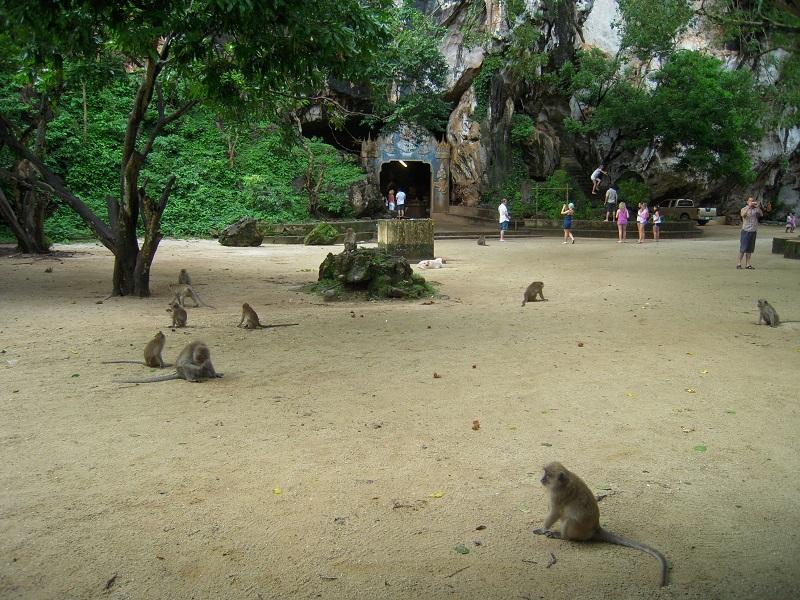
[{"x1": 322, "y1": 0, "x2": 800, "y2": 214}]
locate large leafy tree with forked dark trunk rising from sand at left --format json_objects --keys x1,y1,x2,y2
[{"x1": 0, "y1": 0, "x2": 389, "y2": 296}]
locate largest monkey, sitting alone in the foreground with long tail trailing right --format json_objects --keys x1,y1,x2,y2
[{"x1": 533, "y1": 462, "x2": 667, "y2": 587}]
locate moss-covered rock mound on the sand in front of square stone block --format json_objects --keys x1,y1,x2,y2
[{"x1": 313, "y1": 248, "x2": 433, "y2": 299}]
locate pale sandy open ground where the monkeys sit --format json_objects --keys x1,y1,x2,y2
[{"x1": 0, "y1": 225, "x2": 800, "y2": 599}]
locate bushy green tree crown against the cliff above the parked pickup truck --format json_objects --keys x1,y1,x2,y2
[{"x1": 565, "y1": 50, "x2": 764, "y2": 181}]
